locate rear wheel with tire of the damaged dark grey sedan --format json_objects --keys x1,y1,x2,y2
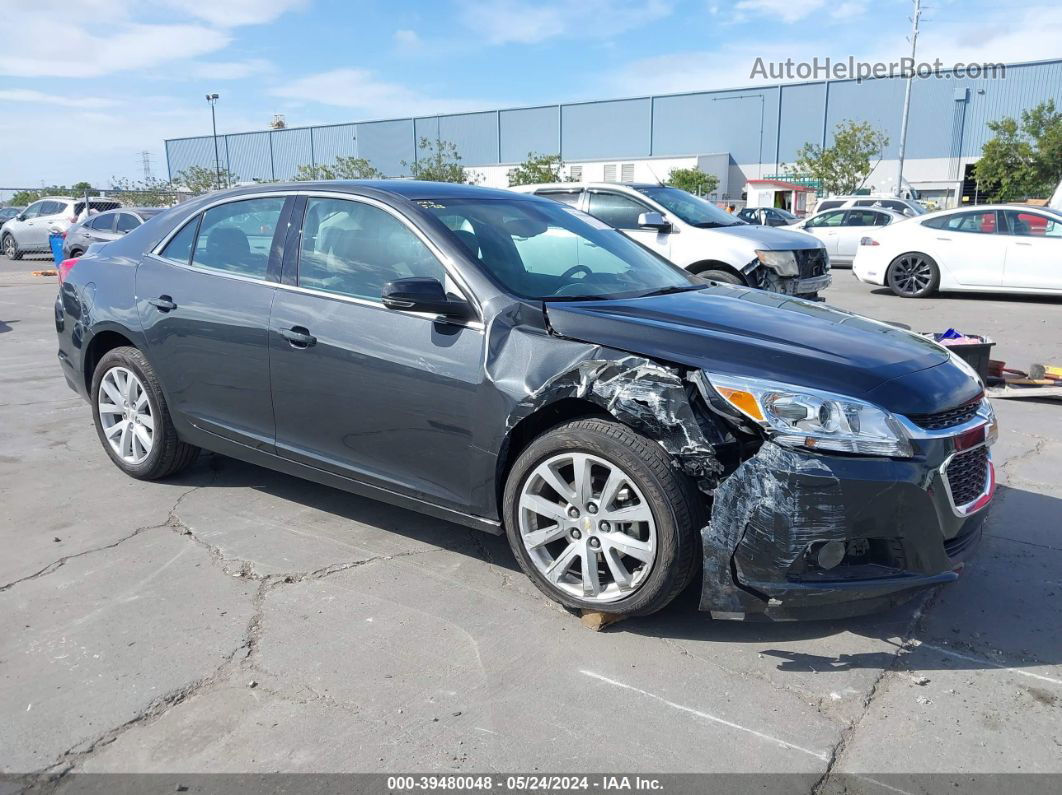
[{"x1": 91, "y1": 347, "x2": 199, "y2": 480}]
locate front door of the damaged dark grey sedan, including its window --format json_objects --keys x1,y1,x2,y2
[{"x1": 270, "y1": 197, "x2": 483, "y2": 509}]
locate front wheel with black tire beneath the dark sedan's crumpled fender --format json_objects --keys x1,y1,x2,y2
[{"x1": 503, "y1": 419, "x2": 704, "y2": 616}]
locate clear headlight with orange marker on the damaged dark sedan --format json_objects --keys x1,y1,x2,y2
[{"x1": 701, "y1": 373, "x2": 913, "y2": 459}]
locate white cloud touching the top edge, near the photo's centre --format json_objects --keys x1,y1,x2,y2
[{"x1": 460, "y1": 0, "x2": 671, "y2": 45}]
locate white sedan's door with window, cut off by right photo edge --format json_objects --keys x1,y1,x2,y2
[{"x1": 1003, "y1": 210, "x2": 1062, "y2": 291}]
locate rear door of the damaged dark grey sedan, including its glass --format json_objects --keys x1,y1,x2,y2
[{"x1": 136, "y1": 194, "x2": 287, "y2": 451}]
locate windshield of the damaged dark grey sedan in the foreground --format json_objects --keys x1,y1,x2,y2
[{"x1": 416, "y1": 197, "x2": 704, "y2": 300}]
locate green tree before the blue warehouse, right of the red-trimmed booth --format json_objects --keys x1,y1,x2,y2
[{"x1": 785, "y1": 120, "x2": 889, "y2": 194}]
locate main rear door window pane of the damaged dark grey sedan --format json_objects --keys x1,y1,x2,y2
[{"x1": 192, "y1": 196, "x2": 285, "y2": 279}]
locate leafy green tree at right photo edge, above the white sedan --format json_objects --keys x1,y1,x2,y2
[{"x1": 974, "y1": 100, "x2": 1062, "y2": 202}]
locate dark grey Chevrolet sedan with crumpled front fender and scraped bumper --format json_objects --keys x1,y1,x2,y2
[{"x1": 55, "y1": 180, "x2": 995, "y2": 618}]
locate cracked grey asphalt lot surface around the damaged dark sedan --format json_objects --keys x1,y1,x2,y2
[{"x1": 0, "y1": 251, "x2": 1062, "y2": 793}]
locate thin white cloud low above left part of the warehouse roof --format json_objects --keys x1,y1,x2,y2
[{"x1": 270, "y1": 69, "x2": 494, "y2": 118}]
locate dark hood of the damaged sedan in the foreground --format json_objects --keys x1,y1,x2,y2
[{"x1": 546, "y1": 286, "x2": 981, "y2": 414}]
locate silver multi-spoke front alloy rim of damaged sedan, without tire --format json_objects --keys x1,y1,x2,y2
[{"x1": 519, "y1": 452, "x2": 656, "y2": 604}]
